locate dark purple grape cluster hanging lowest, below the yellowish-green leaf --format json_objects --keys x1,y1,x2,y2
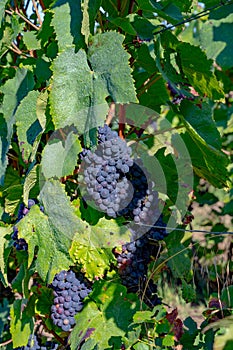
[{"x1": 51, "y1": 271, "x2": 91, "y2": 332}]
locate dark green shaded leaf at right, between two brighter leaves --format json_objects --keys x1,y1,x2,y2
[{"x1": 180, "y1": 100, "x2": 222, "y2": 150}]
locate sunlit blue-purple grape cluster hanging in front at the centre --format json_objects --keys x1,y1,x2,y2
[{"x1": 82, "y1": 125, "x2": 133, "y2": 217}]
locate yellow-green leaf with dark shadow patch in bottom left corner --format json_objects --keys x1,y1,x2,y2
[{"x1": 10, "y1": 299, "x2": 33, "y2": 348}]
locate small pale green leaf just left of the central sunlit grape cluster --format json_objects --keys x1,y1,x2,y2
[{"x1": 41, "y1": 132, "x2": 82, "y2": 179}]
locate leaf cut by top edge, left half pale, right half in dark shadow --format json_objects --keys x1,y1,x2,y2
[{"x1": 51, "y1": 0, "x2": 85, "y2": 51}]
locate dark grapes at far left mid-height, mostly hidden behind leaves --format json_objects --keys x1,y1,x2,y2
[{"x1": 11, "y1": 199, "x2": 44, "y2": 251}]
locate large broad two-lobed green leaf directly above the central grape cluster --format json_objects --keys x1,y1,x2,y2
[{"x1": 50, "y1": 32, "x2": 136, "y2": 133}]
